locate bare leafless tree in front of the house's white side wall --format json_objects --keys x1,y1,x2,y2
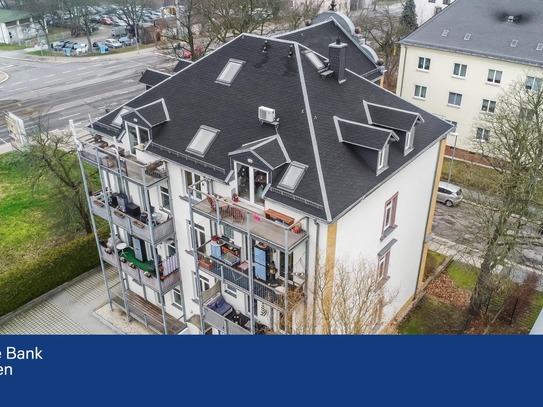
[{"x1": 292, "y1": 257, "x2": 397, "y2": 335}]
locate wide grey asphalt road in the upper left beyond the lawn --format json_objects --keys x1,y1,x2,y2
[{"x1": 0, "y1": 27, "x2": 174, "y2": 144}]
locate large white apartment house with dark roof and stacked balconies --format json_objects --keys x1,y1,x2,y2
[{"x1": 77, "y1": 14, "x2": 452, "y2": 334}]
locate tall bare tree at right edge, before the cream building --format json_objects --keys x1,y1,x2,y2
[{"x1": 469, "y1": 72, "x2": 543, "y2": 317}]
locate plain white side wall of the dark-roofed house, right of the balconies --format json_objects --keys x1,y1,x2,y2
[{"x1": 336, "y1": 143, "x2": 439, "y2": 322}]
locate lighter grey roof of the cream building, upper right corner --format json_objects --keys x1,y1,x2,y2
[{"x1": 400, "y1": 0, "x2": 543, "y2": 66}]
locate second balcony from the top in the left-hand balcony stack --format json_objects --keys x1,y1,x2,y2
[{"x1": 91, "y1": 197, "x2": 174, "y2": 243}]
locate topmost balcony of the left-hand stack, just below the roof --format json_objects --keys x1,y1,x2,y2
[{"x1": 80, "y1": 138, "x2": 168, "y2": 186}]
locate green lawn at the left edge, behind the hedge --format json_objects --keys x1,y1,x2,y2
[{"x1": 0, "y1": 153, "x2": 85, "y2": 273}]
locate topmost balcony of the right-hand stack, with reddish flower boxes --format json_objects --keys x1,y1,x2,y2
[{"x1": 191, "y1": 193, "x2": 308, "y2": 249}]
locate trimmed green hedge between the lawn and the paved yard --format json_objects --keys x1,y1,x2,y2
[{"x1": 0, "y1": 234, "x2": 100, "y2": 317}]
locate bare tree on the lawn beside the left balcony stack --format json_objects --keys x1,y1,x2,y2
[{"x1": 12, "y1": 115, "x2": 97, "y2": 234}]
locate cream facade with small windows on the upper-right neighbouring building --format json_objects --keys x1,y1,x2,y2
[{"x1": 396, "y1": 45, "x2": 541, "y2": 152}]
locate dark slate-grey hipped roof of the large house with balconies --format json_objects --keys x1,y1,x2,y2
[{"x1": 91, "y1": 34, "x2": 452, "y2": 222}]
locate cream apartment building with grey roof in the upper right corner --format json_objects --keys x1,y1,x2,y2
[{"x1": 396, "y1": 0, "x2": 543, "y2": 158}]
